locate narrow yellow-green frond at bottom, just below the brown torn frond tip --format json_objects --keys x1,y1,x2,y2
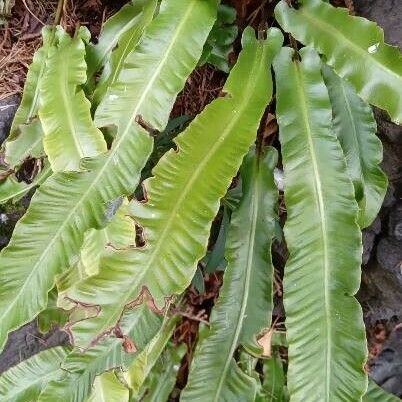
[{"x1": 124, "y1": 316, "x2": 178, "y2": 397}]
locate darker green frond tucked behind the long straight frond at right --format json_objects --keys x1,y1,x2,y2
[{"x1": 323, "y1": 65, "x2": 388, "y2": 228}]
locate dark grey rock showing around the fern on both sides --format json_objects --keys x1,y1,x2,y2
[{"x1": 0, "y1": 0, "x2": 402, "y2": 396}]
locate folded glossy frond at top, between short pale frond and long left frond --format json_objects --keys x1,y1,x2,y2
[{"x1": 92, "y1": 0, "x2": 156, "y2": 105}]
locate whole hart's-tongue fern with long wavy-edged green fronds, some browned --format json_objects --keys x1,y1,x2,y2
[{"x1": 0, "y1": 0, "x2": 402, "y2": 402}]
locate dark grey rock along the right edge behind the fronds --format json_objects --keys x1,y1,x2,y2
[{"x1": 354, "y1": 0, "x2": 402, "y2": 397}]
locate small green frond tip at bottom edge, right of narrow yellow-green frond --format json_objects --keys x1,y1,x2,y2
[{"x1": 139, "y1": 345, "x2": 186, "y2": 402}]
